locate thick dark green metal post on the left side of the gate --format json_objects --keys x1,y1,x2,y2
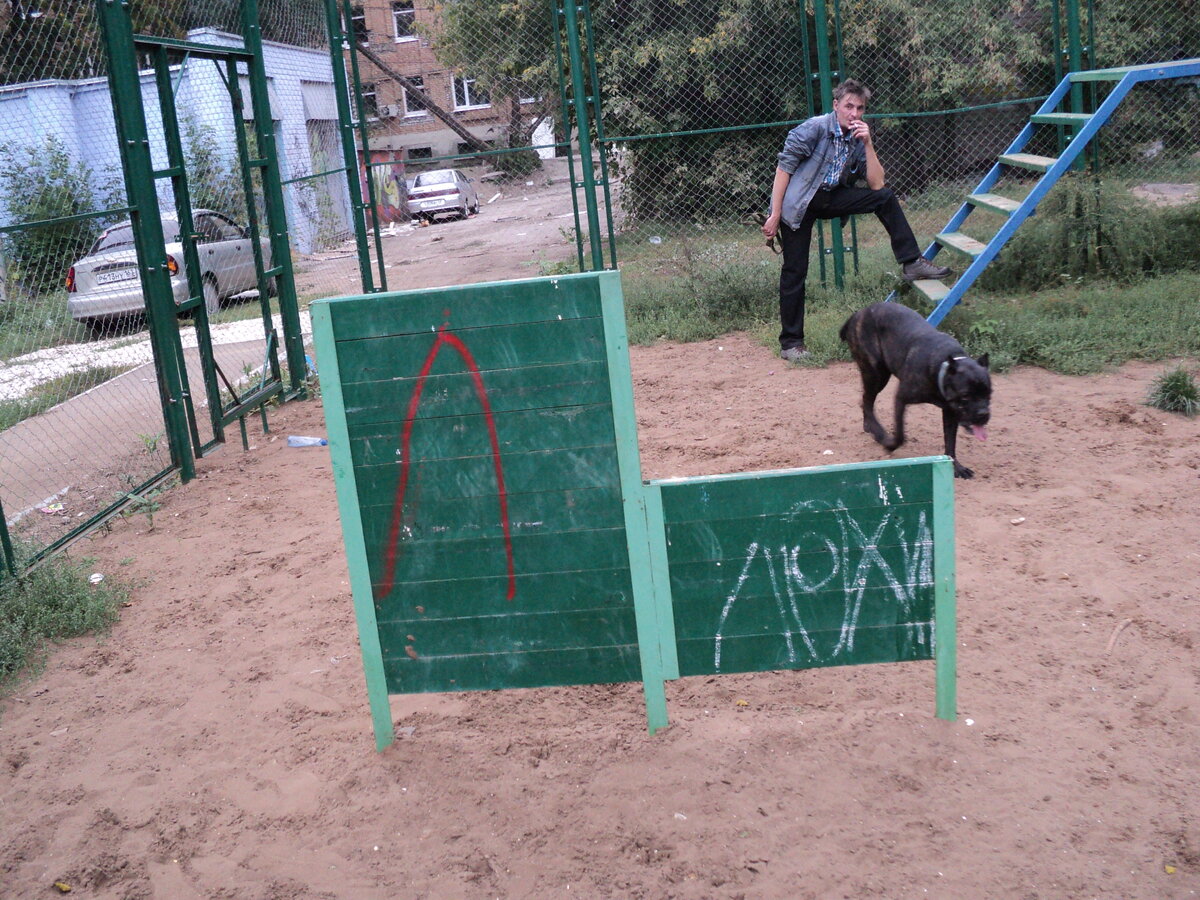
[{"x1": 96, "y1": 0, "x2": 196, "y2": 481}]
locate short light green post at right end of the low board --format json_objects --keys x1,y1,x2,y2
[{"x1": 932, "y1": 457, "x2": 958, "y2": 721}]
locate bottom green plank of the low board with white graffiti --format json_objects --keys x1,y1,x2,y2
[{"x1": 679, "y1": 623, "x2": 934, "y2": 676}]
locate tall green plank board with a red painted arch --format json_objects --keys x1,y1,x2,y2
[{"x1": 313, "y1": 274, "x2": 665, "y2": 743}]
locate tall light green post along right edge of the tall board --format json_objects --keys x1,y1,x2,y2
[{"x1": 600, "y1": 272, "x2": 674, "y2": 734}]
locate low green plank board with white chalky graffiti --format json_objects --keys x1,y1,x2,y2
[{"x1": 652, "y1": 457, "x2": 954, "y2": 707}]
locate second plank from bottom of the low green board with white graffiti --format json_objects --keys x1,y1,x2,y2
[{"x1": 676, "y1": 578, "x2": 934, "y2": 641}]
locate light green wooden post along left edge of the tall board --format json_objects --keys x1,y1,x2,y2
[{"x1": 312, "y1": 304, "x2": 396, "y2": 750}]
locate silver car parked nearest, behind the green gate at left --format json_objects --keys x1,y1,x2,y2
[{"x1": 66, "y1": 209, "x2": 274, "y2": 331}]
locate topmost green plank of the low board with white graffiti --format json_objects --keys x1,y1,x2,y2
[{"x1": 653, "y1": 460, "x2": 932, "y2": 522}]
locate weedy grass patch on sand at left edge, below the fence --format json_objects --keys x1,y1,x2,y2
[{"x1": 0, "y1": 556, "x2": 128, "y2": 690}]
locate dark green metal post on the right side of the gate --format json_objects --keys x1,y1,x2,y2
[{"x1": 240, "y1": 0, "x2": 308, "y2": 397}]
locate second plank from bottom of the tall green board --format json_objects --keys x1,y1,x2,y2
[{"x1": 379, "y1": 601, "x2": 637, "y2": 656}]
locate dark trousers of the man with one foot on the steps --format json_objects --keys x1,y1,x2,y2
[{"x1": 779, "y1": 187, "x2": 920, "y2": 350}]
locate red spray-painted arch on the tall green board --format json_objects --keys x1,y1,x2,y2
[{"x1": 376, "y1": 325, "x2": 517, "y2": 600}]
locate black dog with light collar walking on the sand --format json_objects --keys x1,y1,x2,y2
[{"x1": 840, "y1": 304, "x2": 991, "y2": 478}]
